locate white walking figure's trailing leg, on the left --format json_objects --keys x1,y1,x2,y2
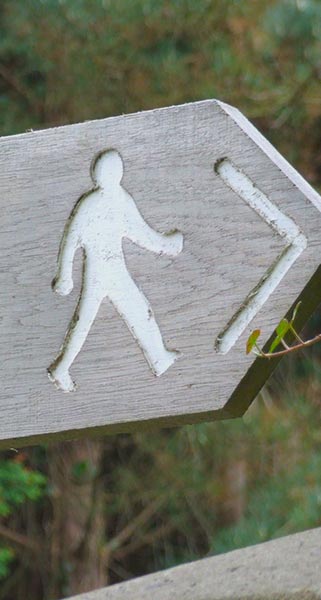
[{"x1": 48, "y1": 281, "x2": 103, "y2": 392}]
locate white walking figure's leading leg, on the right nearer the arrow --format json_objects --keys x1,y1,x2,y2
[{"x1": 108, "y1": 269, "x2": 179, "y2": 375}]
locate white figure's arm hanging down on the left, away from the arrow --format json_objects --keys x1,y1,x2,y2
[{"x1": 52, "y1": 208, "x2": 80, "y2": 296}]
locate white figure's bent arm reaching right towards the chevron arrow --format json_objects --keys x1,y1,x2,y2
[{"x1": 126, "y1": 196, "x2": 183, "y2": 256}]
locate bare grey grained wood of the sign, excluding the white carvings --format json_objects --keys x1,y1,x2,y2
[{"x1": 0, "y1": 100, "x2": 321, "y2": 446}]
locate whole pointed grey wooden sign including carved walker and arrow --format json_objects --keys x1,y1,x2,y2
[{"x1": 0, "y1": 100, "x2": 321, "y2": 446}]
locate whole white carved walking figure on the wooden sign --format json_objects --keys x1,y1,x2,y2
[{"x1": 48, "y1": 150, "x2": 183, "y2": 391}]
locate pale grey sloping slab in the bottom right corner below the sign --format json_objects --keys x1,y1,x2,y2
[{"x1": 65, "y1": 529, "x2": 321, "y2": 600}]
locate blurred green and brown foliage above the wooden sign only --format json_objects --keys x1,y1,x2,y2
[{"x1": 0, "y1": 0, "x2": 320, "y2": 147}]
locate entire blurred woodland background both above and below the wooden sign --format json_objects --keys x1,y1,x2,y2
[{"x1": 0, "y1": 0, "x2": 321, "y2": 600}]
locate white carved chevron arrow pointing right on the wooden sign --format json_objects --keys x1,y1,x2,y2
[{"x1": 215, "y1": 158, "x2": 307, "y2": 354}]
